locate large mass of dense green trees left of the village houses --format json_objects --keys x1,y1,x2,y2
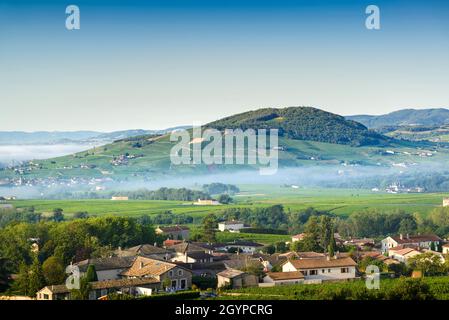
[{"x1": 0, "y1": 217, "x2": 158, "y2": 294}]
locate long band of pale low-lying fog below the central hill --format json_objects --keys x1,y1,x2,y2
[{"x1": 0, "y1": 165, "x2": 438, "y2": 198}]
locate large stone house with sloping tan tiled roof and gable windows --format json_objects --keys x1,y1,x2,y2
[{"x1": 120, "y1": 257, "x2": 192, "y2": 290}]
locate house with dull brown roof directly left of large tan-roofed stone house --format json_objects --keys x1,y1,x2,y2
[{"x1": 74, "y1": 256, "x2": 135, "y2": 281}]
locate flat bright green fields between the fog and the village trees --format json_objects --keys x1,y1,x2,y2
[{"x1": 9, "y1": 185, "x2": 446, "y2": 217}]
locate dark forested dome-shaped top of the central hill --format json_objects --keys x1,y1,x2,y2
[{"x1": 207, "y1": 107, "x2": 393, "y2": 146}]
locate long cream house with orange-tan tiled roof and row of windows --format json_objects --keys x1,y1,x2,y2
[{"x1": 282, "y1": 256, "x2": 357, "y2": 282}]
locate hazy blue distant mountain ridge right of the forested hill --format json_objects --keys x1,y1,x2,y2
[{"x1": 345, "y1": 108, "x2": 449, "y2": 129}]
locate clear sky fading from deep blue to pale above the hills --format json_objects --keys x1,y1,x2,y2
[{"x1": 0, "y1": 0, "x2": 449, "y2": 131}]
